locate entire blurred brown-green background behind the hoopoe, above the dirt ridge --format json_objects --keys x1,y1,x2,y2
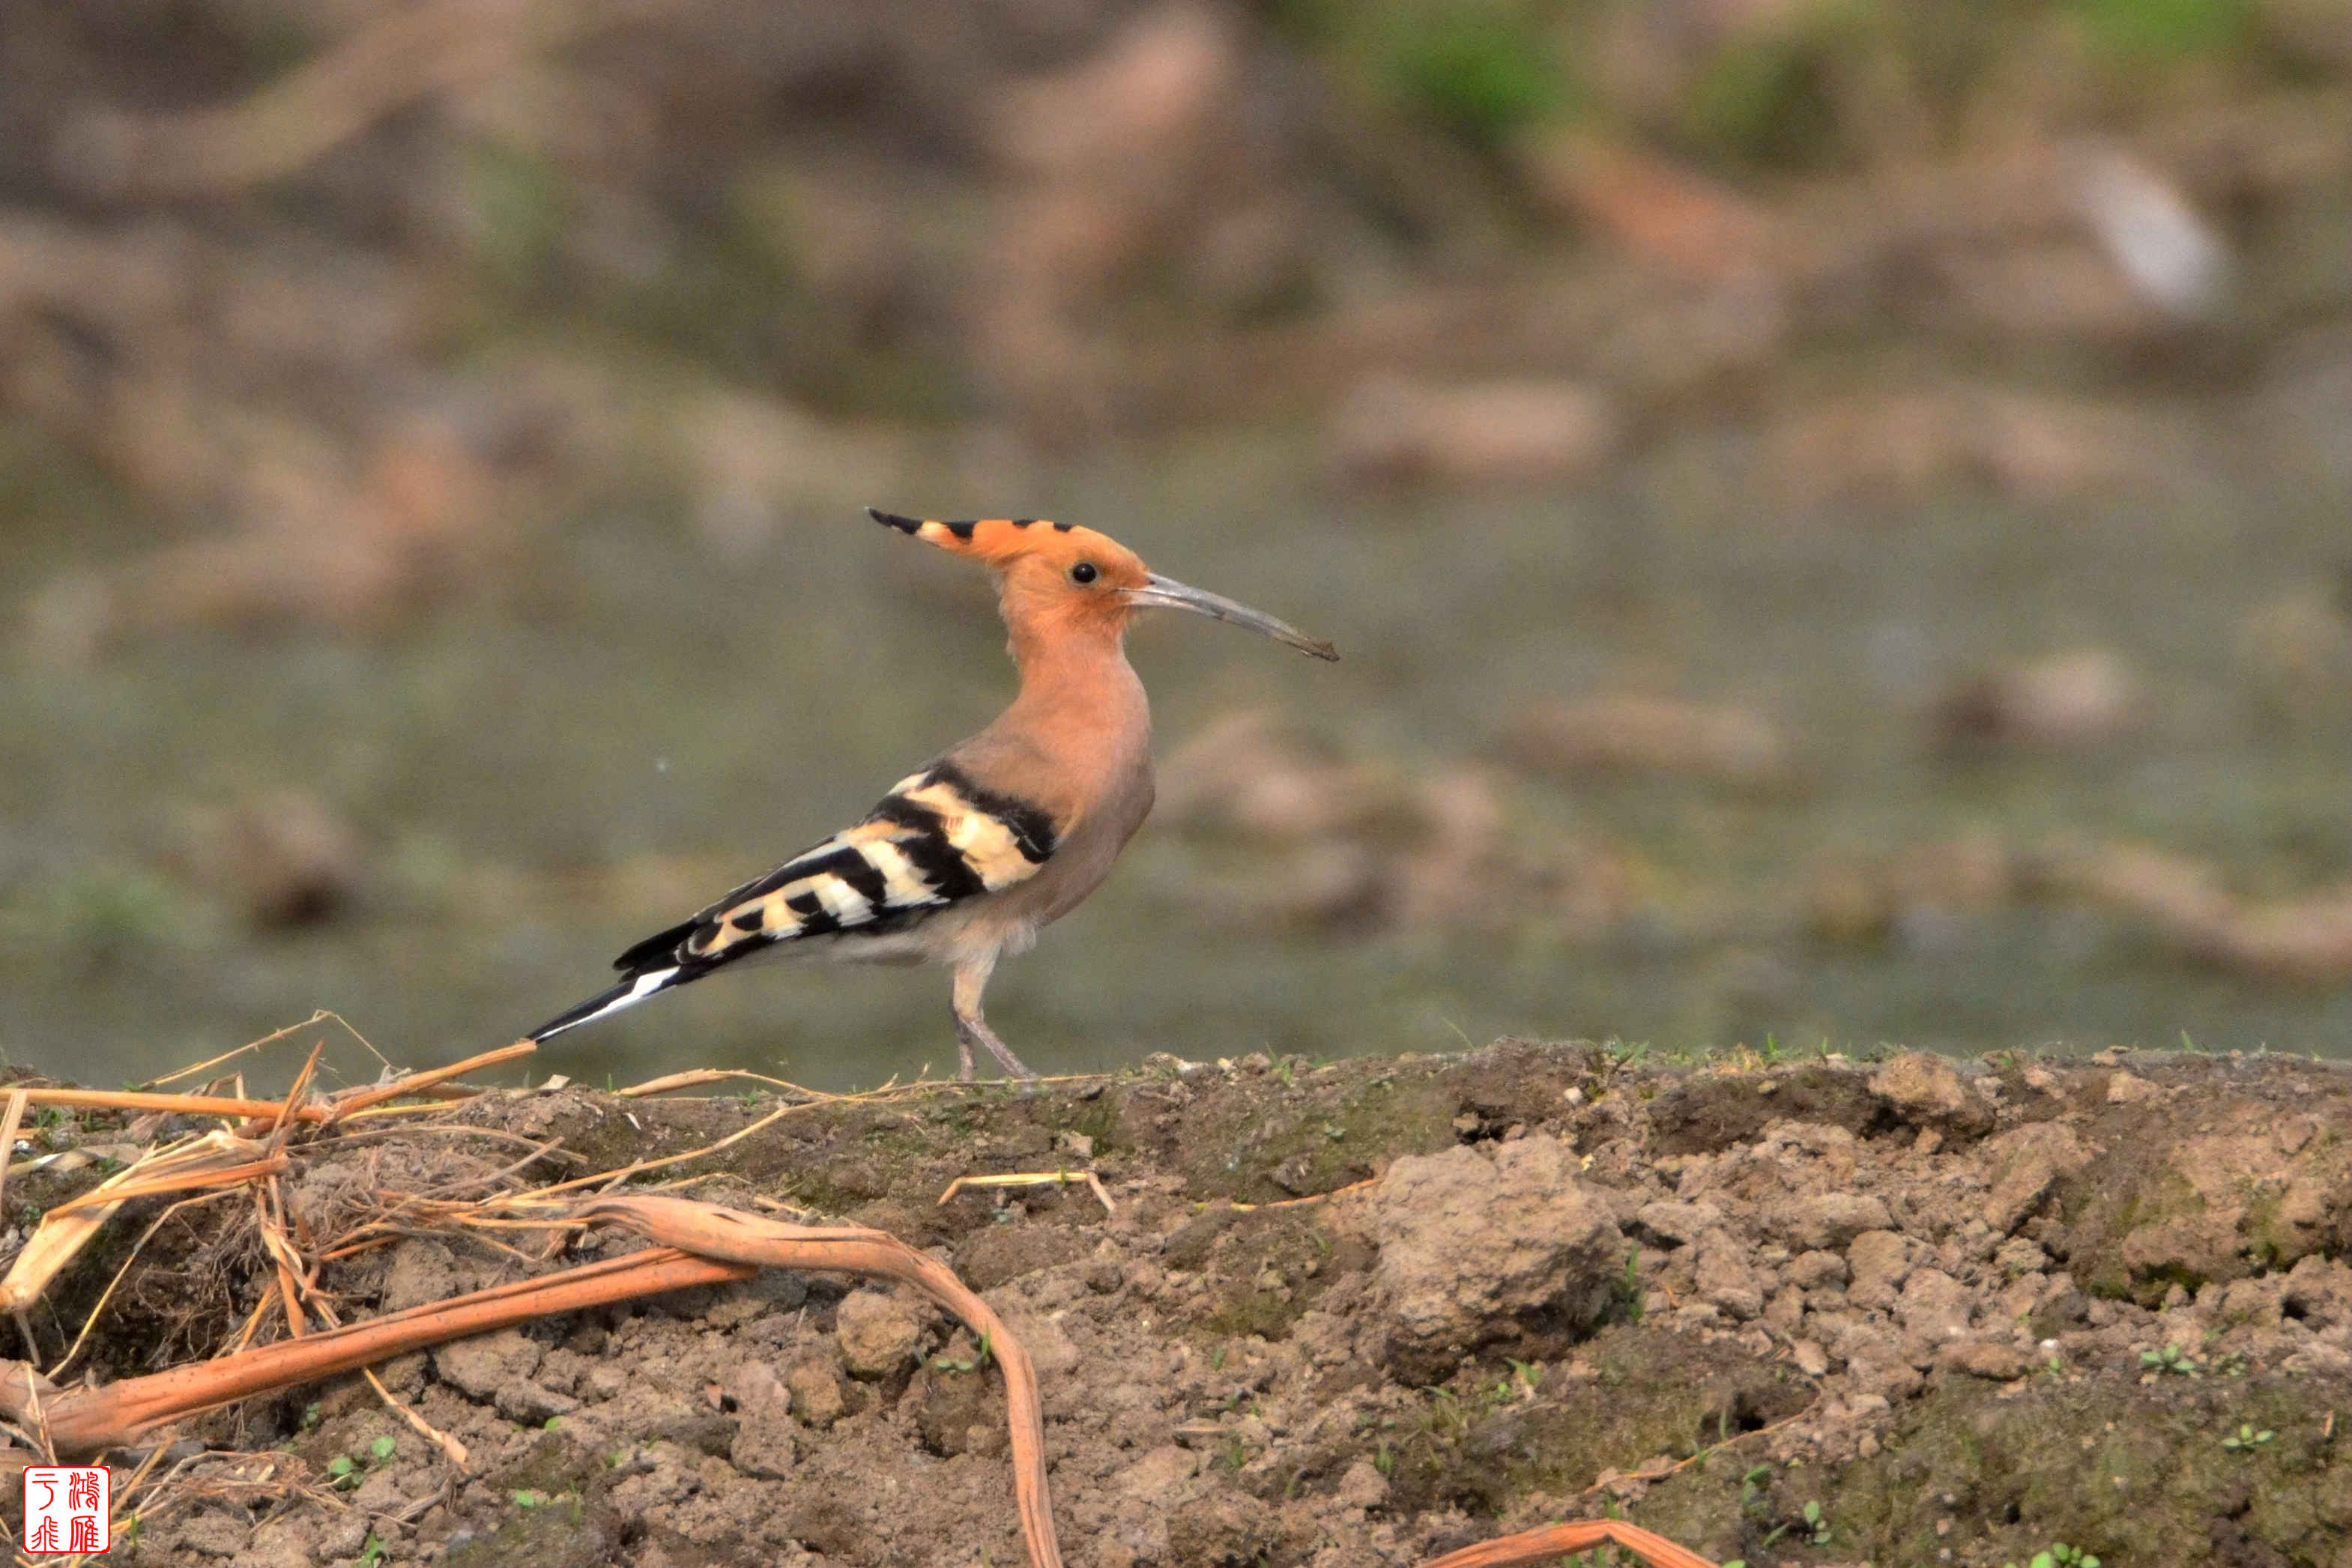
[{"x1": 0, "y1": 0, "x2": 2352, "y2": 1086}]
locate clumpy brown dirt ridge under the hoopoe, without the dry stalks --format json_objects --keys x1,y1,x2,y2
[{"x1": 10, "y1": 1041, "x2": 2352, "y2": 1568}]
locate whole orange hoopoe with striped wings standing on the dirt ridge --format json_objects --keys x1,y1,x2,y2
[{"x1": 524, "y1": 508, "x2": 1338, "y2": 1079}]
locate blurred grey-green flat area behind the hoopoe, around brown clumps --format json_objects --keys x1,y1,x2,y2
[{"x1": 0, "y1": 423, "x2": 2352, "y2": 1086}]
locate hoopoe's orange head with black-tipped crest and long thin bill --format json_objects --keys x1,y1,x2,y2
[{"x1": 865, "y1": 508, "x2": 1338, "y2": 659}]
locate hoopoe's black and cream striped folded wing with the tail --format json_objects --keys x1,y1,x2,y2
[{"x1": 527, "y1": 762, "x2": 1059, "y2": 1039}]
